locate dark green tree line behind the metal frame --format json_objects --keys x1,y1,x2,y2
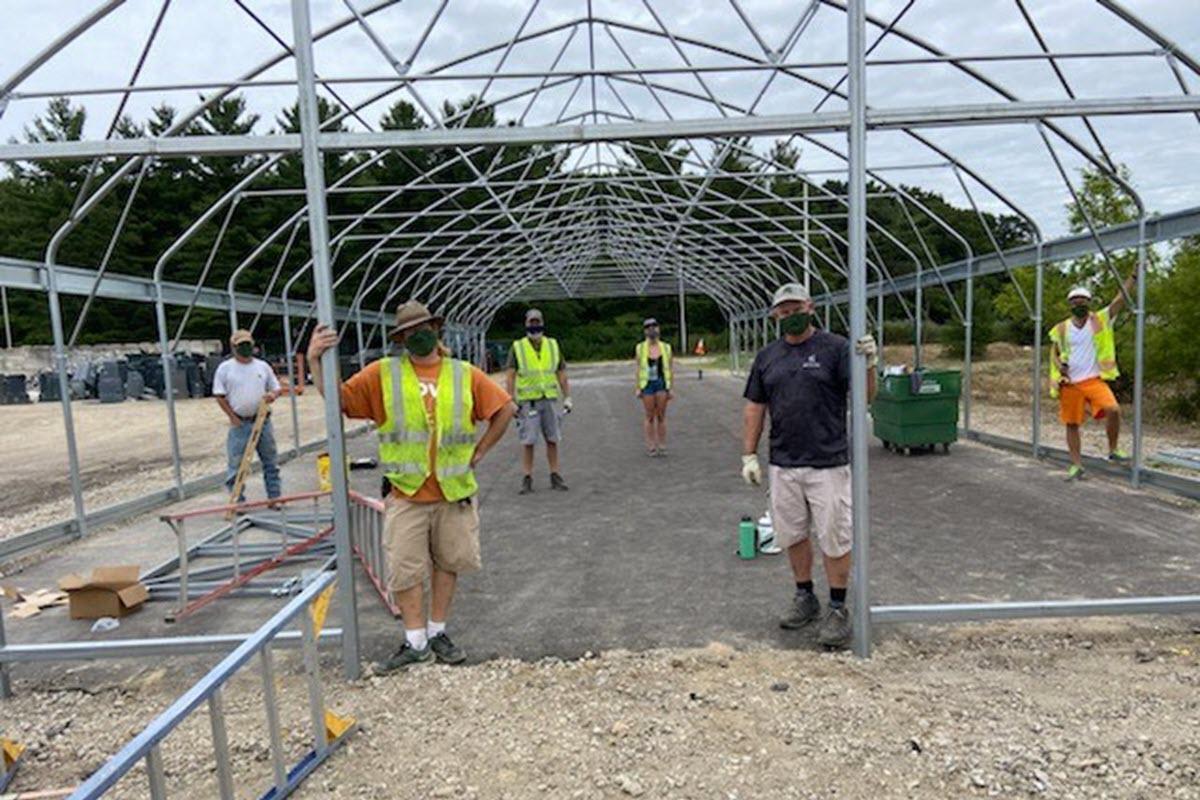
[{"x1": 0, "y1": 95, "x2": 1200, "y2": 417}]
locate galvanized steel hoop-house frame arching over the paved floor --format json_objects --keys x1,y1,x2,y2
[{"x1": 0, "y1": 0, "x2": 1200, "y2": 675}]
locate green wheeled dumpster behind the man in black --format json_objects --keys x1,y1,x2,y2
[{"x1": 871, "y1": 369, "x2": 962, "y2": 453}]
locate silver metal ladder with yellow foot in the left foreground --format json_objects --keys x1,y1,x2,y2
[{"x1": 71, "y1": 572, "x2": 355, "y2": 800}]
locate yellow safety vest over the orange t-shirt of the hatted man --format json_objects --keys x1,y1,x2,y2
[{"x1": 379, "y1": 356, "x2": 479, "y2": 503}]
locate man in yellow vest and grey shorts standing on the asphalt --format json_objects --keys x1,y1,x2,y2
[{"x1": 505, "y1": 308, "x2": 574, "y2": 494}]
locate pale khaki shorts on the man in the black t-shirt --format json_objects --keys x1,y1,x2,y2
[{"x1": 770, "y1": 464, "x2": 854, "y2": 558}]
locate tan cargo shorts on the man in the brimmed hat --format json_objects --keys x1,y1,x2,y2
[{"x1": 383, "y1": 492, "x2": 481, "y2": 591}]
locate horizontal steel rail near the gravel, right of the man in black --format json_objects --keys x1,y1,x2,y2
[{"x1": 871, "y1": 595, "x2": 1200, "y2": 624}]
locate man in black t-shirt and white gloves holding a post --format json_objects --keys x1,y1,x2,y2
[{"x1": 742, "y1": 283, "x2": 877, "y2": 648}]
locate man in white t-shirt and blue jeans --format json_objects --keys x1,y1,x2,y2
[{"x1": 212, "y1": 330, "x2": 282, "y2": 503}]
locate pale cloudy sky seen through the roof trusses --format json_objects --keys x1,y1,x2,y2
[{"x1": 0, "y1": 0, "x2": 1200, "y2": 234}]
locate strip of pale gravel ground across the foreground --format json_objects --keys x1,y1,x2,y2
[{"x1": 0, "y1": 620, "x2": 1200, "y2": 800}]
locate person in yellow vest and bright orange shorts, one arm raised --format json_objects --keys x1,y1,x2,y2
[{"x1": 1050, "y1": 272, "x2": 1138, "y2": 481}]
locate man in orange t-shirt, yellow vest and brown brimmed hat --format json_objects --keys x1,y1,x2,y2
[{"x1": 308, "y1": 300, "x2": 517, "y2": 674}]
